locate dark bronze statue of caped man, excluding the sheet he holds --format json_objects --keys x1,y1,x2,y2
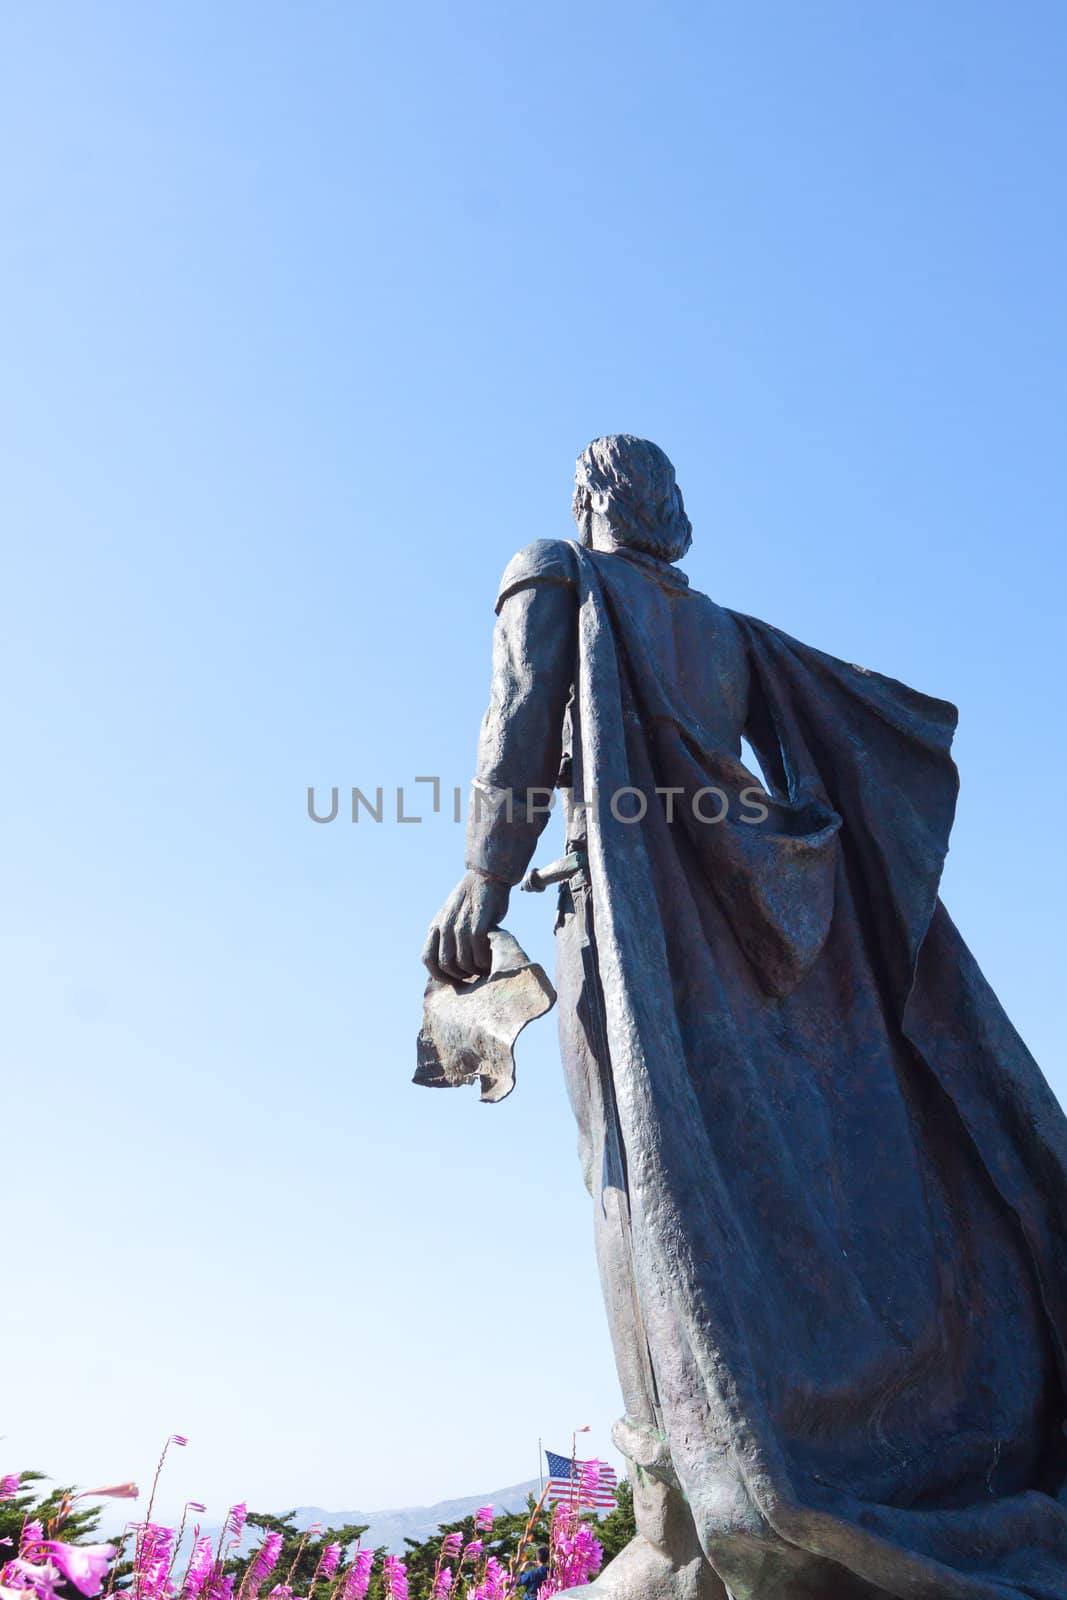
[{"x1": 424, "y1": 435, "x2": 1067, "y2": 1600}]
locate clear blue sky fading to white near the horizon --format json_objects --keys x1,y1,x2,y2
[{"x1": 0, "y1": 0, "x2": 1067, "y2": 1510}]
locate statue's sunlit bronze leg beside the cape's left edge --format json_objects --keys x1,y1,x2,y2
[{"x1": 557, "y1": 890, "x2": 728, "y2": 1600}]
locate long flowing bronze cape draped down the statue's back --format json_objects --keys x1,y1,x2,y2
[{"x1": 573, "y1": 546, "x2": 1067, "y2": 1600}]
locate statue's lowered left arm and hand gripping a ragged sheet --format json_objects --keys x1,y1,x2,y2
[{"x1": 422, "y1": 562, "x2": 577, "y2": 979}]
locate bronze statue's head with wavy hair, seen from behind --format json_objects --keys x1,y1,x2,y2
[{"x1": 573, "y1": 434, "x2": 693, "y2": 562}]
